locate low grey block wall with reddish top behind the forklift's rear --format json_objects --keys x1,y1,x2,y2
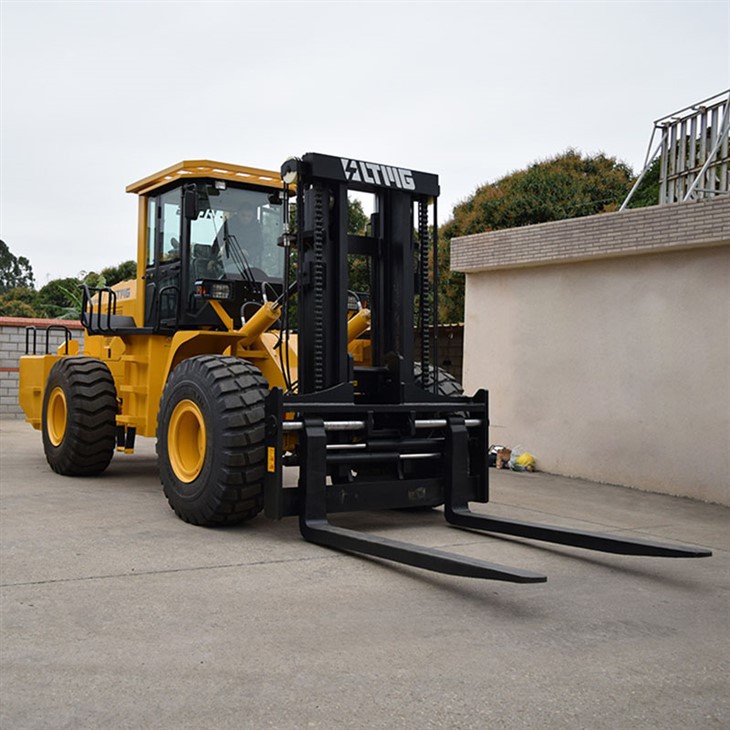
[{"x1": 0, "y1": 317, "x2": 84, "y2": 418}]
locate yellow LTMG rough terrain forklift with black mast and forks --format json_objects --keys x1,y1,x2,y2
[{"x1": 20, "y1": 153, "x2": 711, "y2": 583}]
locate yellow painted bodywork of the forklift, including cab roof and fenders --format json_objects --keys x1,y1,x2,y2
[{"x1": 19, "y1": 160, "x2": 369, "y2": 436}]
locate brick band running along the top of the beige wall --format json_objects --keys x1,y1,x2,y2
[{"x1": 451, "y1": 195, "x2": 730, "y2": 273}]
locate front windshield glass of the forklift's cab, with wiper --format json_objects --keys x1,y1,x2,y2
[{"x1": 190, "y1": 185, "x2": 284, "y2": 281}]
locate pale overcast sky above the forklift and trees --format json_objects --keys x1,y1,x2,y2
[{"x1": 0, "y1": 0, "x2": 730, "y2": 287}]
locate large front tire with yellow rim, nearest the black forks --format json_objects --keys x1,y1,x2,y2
[{"x1": 157, "y1": 355, "x2": 268, "y2": 527}]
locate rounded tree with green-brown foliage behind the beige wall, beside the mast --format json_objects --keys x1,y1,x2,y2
[{"x1": 432, "y1": 149, "x2": 634, "y2": 322}]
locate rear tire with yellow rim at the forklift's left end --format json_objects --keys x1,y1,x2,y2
[{"x1": 42, "y1": 357, "x2": 117, "y2": 476}]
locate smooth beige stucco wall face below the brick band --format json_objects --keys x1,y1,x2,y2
[{"x1": 456, "y1": 199, "x2": 730, "y2": 504}]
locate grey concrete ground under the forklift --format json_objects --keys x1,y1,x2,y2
[{"x1": 0, "y1": 421, "x2": 730, "y2": 730}]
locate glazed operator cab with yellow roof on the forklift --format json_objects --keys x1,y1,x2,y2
[{"x1": 127, "y1": 161, "x2": 284, "y2": 332}]
